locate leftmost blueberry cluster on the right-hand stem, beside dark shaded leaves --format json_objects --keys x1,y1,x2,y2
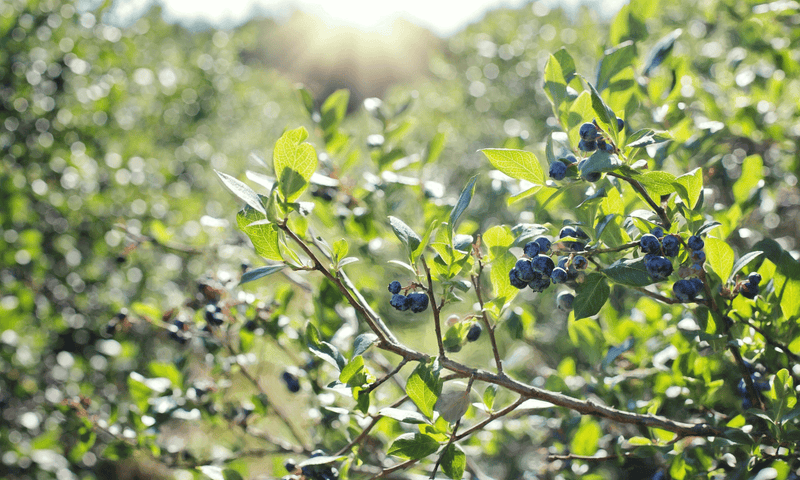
[{"x1": 508, "y1": 226, "x2": 589, "y2": 311}]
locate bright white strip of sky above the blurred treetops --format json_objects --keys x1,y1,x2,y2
[{"x1": 108, "y1": 0, "x2": 625, "y2": 37}]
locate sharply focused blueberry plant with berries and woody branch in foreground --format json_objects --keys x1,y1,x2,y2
[{"x1": 198, "y1": 45, "x2": 800, "y2": 479}]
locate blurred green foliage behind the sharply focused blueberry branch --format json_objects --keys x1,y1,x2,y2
[{"x1": 0, "y1": 0, "x2": 800, "y2": 480}]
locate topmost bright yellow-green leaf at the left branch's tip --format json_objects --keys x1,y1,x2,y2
[{"x1": 272, "y1": 127, "x2": 317, "y2": 203}]
